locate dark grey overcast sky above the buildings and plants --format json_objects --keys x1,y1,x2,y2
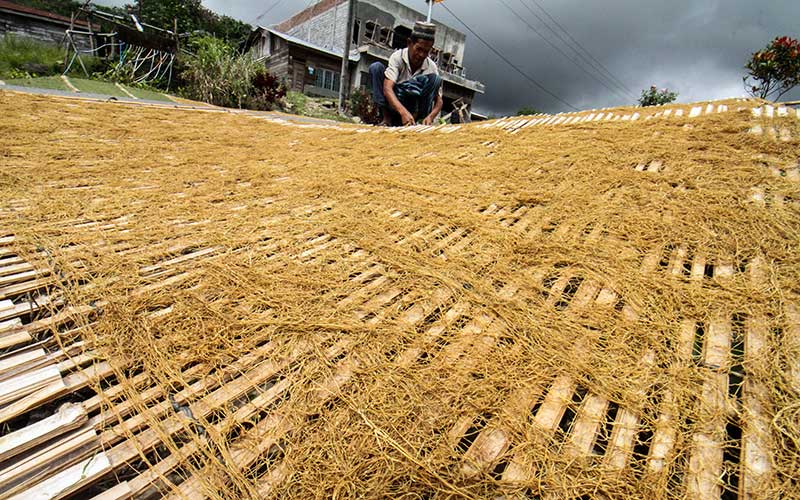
[{"x1": 96, "y1": 0, "x2": 800, "y2": 115}]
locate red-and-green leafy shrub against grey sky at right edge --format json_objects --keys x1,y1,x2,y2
[{"x1": 744, "y1": 36, "x2": 800, "y2": 101}]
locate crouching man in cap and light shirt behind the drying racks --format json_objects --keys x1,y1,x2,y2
[{"x1": 369, "y1": 22, "x2": 443, "y2": 126}]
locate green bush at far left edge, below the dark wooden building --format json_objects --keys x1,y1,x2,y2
[{"x1": 0, "y1": 34, "x2": 64, "y2": 78}]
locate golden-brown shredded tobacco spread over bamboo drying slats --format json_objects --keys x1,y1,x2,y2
[{"x1": 0, "y1": 92, "x2": 800, "y2": 499}]
